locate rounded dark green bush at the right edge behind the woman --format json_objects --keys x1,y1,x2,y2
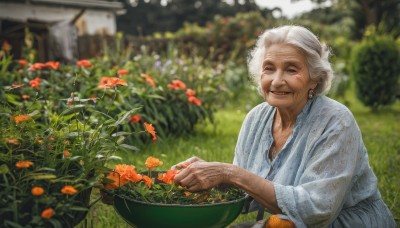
[{"x1": 351, "y1": 32, "x2": 400, "y2": 110}]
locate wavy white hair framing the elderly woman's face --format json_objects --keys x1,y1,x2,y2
[{"x1": 247, "y1": 25, "x2": 333, "y2": 95}]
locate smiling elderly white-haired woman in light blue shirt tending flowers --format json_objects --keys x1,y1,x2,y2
[{"x1": 175, "y1": 26, "x2": 396, "y2": 227}]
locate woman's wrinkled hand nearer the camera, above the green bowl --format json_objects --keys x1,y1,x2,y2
[{"x1": 174, "y1": 161, "x2": 231, "y2": 192}]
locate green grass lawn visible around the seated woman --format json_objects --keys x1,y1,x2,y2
[{"x1": 79, "y1": 88, "x2": 400, "y2": 227}]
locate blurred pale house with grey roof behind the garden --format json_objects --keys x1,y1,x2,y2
[{"x1": 0, "y1": 0, "x2": 125, "y2": 62}]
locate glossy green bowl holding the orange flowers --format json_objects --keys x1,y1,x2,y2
[{"x1": 114, "y1": 192, "x2": 246, "y2": 228}]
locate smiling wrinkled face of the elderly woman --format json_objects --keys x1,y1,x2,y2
[{"x1": 261, "y1": 43, "x2": 317, "y2": 113}]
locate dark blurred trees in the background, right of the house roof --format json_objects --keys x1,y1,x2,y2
[{"x1": 117, "y1": 0, "x2": 260, "y2": 35}]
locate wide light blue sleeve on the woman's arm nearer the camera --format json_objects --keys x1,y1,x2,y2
[{"x1": 274, "y1": 113, "x2": 363, "y2": 227}]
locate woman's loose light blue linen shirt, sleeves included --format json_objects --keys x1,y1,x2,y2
[{"x1": 233, "y1": 96, "x2": 396, "y2": 227}]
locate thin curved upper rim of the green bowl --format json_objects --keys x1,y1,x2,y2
[{"x1": 114, "y1": 194, "x2": 248, "y2": 208}]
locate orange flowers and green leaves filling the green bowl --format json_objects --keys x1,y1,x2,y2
[{"x1": 103, "y1": 157, "x2": 244, "y2": 205}]
